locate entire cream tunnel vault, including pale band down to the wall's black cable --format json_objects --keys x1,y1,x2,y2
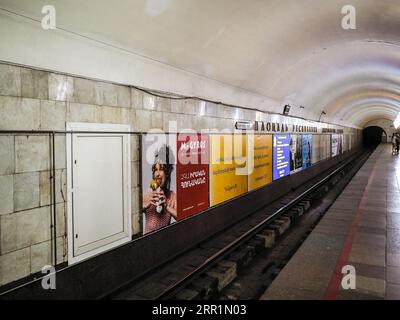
[{"x1": 0, "y1": 0, "x2": 400, "y2": 134}]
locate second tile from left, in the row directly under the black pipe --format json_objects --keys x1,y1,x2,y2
[{"x1": 15, "y1": 136, "x2": 50, "y2": 173}]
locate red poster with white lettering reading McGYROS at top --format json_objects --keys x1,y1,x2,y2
[{"x1": 176, "y1": 134, "x2": 209, "y2": 220}]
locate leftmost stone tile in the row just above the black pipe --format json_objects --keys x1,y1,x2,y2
[{"x1": 0, "y1": 96, "x2": 40, "y2": 130}]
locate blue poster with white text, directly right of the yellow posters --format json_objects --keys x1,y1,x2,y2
[{"x1": 273, "y1": 134, "x2": 290, "y2": 180}]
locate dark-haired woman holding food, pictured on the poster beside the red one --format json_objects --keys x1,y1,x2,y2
[{"x1": 143, "y1": 145, "x2": 177, "y2": 233}]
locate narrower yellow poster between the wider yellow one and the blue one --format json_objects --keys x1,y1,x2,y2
[{"x1": 248, "y1": 134, "x2": 272, "y2": 191}]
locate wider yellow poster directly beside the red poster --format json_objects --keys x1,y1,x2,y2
[{"x1": 210, "y1": 134, "x2": 247, "y2": 206}]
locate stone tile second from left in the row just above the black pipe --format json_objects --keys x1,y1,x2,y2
[{"x1": 40, "y1": 100, "x2": 67, "y2": 131}]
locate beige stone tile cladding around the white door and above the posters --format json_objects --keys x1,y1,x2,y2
[{"x1": 0, "y1": 63, "x2": 255, "y2": 286}]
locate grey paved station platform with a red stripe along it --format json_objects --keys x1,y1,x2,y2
[{"x1": 261, "y1": 144, "x2": 400, "y2": 300}]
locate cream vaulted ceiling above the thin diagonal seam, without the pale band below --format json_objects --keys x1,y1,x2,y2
[{"x1": 0, "y1": 0, "x2": 400, "y2": 127}]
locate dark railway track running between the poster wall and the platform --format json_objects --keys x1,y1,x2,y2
[{"x1": 105, "y1": 150, "x2": 371, "y2": 300}]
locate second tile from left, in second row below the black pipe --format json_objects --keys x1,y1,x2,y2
[{"x1": 14, "y1": 172, "x2": 40, "y2": 211}]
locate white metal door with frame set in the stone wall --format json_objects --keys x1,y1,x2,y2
[{"x1": 67, "y1": 123, "x2": 131, "y2": 264}]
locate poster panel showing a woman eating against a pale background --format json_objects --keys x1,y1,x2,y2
[{"x1": 142, "y1": 134, "x2": 177, "y2": 234}]
